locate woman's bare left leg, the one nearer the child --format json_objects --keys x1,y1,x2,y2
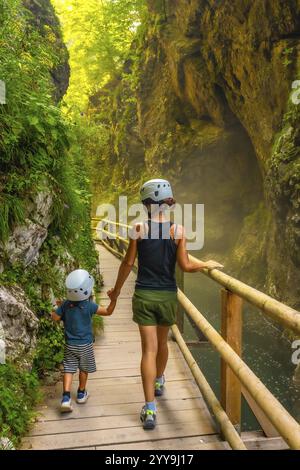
[{"x1": 139, "y1": 325, "x2": 157, "y2": 402}]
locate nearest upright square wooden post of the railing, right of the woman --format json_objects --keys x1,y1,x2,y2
[{"x1": 221, "y1": 289, "x2": 243, "y2": 432}]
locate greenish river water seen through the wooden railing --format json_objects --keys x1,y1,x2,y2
[{"x1": 184, "y1": 273, "x2": 300, "y2": 431}]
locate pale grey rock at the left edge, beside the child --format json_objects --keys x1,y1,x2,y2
[{"x1": 0, "y1": 286, "x2": 38, "y2": 362}]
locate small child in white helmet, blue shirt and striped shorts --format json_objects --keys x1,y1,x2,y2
[{"x1": 51, "y1": 269, "x2": 116, "y2": 413}]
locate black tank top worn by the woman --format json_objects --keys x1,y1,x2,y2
[{"x1": 136, "y1": 220, "x2": 177, "y2": 291}]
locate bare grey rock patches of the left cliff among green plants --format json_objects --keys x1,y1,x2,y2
[{"x1": 0, "y1": 0, "x2": 70, "y2": 366}]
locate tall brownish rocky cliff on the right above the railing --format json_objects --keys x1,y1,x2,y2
[{"x1": 92, "y1": 0, "x2": 300, "y2": 307}]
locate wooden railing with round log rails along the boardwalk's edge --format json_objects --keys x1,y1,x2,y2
[{"x1": 92, "y1": 218, "x2": 300, "y2": 449}]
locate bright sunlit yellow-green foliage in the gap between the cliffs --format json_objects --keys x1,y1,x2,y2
[{"x1": 53, "y1": 0, "x2": 145, "y2": 114}]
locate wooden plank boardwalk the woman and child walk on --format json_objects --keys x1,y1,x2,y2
[{"x1": 22, "y1": 245, "x2": 286, "y2": 450}]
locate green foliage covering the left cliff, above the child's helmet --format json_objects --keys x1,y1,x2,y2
[{"x1": 0, "y1": 0, "x2": 97, "y2": 276}]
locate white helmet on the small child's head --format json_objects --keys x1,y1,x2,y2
[{"x1": 66, "y1": 269, "x2": 94, "y2": 302}]
